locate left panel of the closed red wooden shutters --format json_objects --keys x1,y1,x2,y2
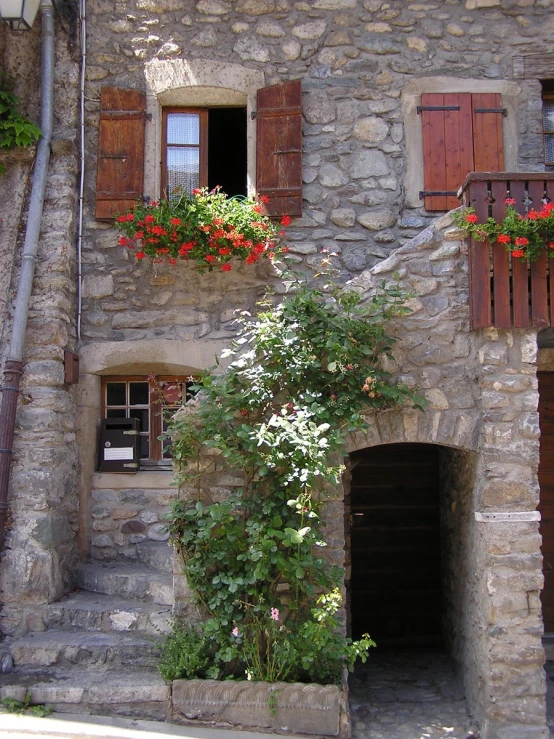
[{"x1": 421, "y1": 93, "x2": 473, "y2": 210}]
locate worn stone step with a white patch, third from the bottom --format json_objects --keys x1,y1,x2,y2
[{"x1": 48, "y1": 590, "x2": 172, "y2": 636}]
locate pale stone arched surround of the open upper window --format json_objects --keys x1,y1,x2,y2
[{"x1": 144, "y1": 59, "x2": 264, "y2": 199}]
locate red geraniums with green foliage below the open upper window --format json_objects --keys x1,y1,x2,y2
[{"x1": 115, "y1": 187, "x2": 290, "y2": 273}]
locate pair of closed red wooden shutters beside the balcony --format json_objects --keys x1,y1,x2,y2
[{"x1": 418, "y1": 93, "x2": 507, "y2": 211}]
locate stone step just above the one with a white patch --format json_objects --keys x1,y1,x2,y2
[{"x1": 77, "y1": 562, "x2": 173, "y2": 606}]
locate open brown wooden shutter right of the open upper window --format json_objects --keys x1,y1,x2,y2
[{"x1": 256, "y1": 80, "x2": 302, "y2": 216}]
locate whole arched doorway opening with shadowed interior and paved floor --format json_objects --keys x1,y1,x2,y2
[{"x1": 345, "y1": 443, "x2": 478, "y2": 737}]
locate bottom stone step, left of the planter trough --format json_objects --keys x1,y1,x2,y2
[{"x1": 0, "y1": 667, "x2": 170, "y2": 721}]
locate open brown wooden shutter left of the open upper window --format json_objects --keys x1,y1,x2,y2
[{"x1": 96, "y1": 87, "x2": 146, "y2": 221}]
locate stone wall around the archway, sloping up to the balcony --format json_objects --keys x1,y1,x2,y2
[{"x1": 349, "y1": 215, "x2": 548, "y2": 739}]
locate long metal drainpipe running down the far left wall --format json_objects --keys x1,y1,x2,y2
[{"x1": 0, "y1": 0, "x2": 54, "y2": 551}]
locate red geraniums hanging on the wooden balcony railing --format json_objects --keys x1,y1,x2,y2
[{"x1": 454, "y1": 198, "x2": 554, "y2": 262}]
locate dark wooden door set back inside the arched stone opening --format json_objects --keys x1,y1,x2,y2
[{"x1": 349, "y1": 444, "x2": 443, "y2": 646}]
